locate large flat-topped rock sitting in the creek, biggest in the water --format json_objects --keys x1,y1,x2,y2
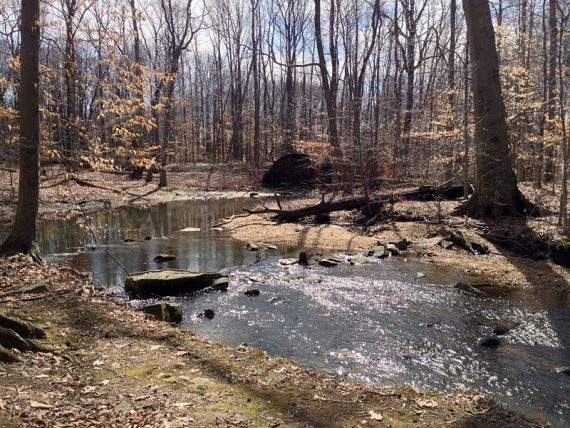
[{"x1": 125, "y1": 270, "x2": 225, "y2": 298}]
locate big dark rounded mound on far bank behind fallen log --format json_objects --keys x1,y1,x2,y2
[{"x1": 261, "y1": 153, "x2": 318, "y2": 187}]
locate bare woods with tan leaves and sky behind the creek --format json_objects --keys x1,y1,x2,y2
[{"x1": 0, "y1": 0, "x2": 570, "y2": 197}]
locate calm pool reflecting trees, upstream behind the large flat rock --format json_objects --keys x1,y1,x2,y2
[{"x1": 15, "y1": 199, "x2": 261, "y2": 286}]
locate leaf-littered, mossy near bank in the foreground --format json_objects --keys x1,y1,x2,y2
[{"x1": 0, "y1": 260, "x2": 540, "y2": 427}]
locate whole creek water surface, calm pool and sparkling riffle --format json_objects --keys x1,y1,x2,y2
[{"x1": 3, "y1": 200, "x2": 570, "y2": 427}]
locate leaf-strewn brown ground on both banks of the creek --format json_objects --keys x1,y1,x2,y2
[{"x1": 0, "y1": 166, "x2": 570, "y2": 427}]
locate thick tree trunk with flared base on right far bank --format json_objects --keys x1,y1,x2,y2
[{"x1": 457, "y1": 0, "x2": 535, "y2": 217}]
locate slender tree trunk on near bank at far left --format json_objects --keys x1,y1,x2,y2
[{"x1": 0, "y1": 0, "x2": 40, "y2": 255}]
